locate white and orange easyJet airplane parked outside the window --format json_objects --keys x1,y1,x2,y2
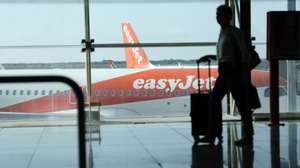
[{"x1": 0, "y1": 22, "x2": 285, "y2": 116}]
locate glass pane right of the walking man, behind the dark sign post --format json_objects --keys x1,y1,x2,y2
[{"x1": 251, "y1": 0, "x2": 287, "y2": 119}]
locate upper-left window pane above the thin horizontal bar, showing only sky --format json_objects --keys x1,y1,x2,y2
[{"x1": 0, "y1": 1, "x2": 84, "y2": 46}]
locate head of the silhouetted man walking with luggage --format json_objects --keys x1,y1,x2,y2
[{"x1": 217, "y1": 5, "x2": 232, "y2": 27}]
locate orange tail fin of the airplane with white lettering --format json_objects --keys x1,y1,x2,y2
[{"x1": 122, "y1": 23, "x2": 150, "y2": 68}]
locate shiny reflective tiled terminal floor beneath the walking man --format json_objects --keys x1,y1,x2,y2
[{"x1": 0, "y1": 122, "x2": 300, "y2": 168}]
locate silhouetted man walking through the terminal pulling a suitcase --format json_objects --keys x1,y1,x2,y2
[{"x1": 199, "y1": 5, "x2": 254, "y2": 145}]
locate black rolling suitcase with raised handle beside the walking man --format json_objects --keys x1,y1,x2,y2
[{"x1": 190, "y1": 55, "x2": 215, "y2": 141}]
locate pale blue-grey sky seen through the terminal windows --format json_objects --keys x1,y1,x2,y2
[{"x1": 0, "y1": 0, "x2": 300, "y2": 63}]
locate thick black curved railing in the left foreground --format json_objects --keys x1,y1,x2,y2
[{"x1": 0, "y1": 76, "x2": 87, "y2": 168}]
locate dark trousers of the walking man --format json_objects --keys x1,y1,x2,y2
[{"x1": 208, "y1": 64, "x2": 254, "y2": 137}]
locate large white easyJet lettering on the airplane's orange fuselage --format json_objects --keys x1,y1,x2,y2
[{"x1": 133, "y1": 75, "x2": 216, "y2": 92}]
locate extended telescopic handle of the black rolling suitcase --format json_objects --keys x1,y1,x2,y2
[{"x1": 196, "y1": 55, "x2": 217, "y2": 93}]
